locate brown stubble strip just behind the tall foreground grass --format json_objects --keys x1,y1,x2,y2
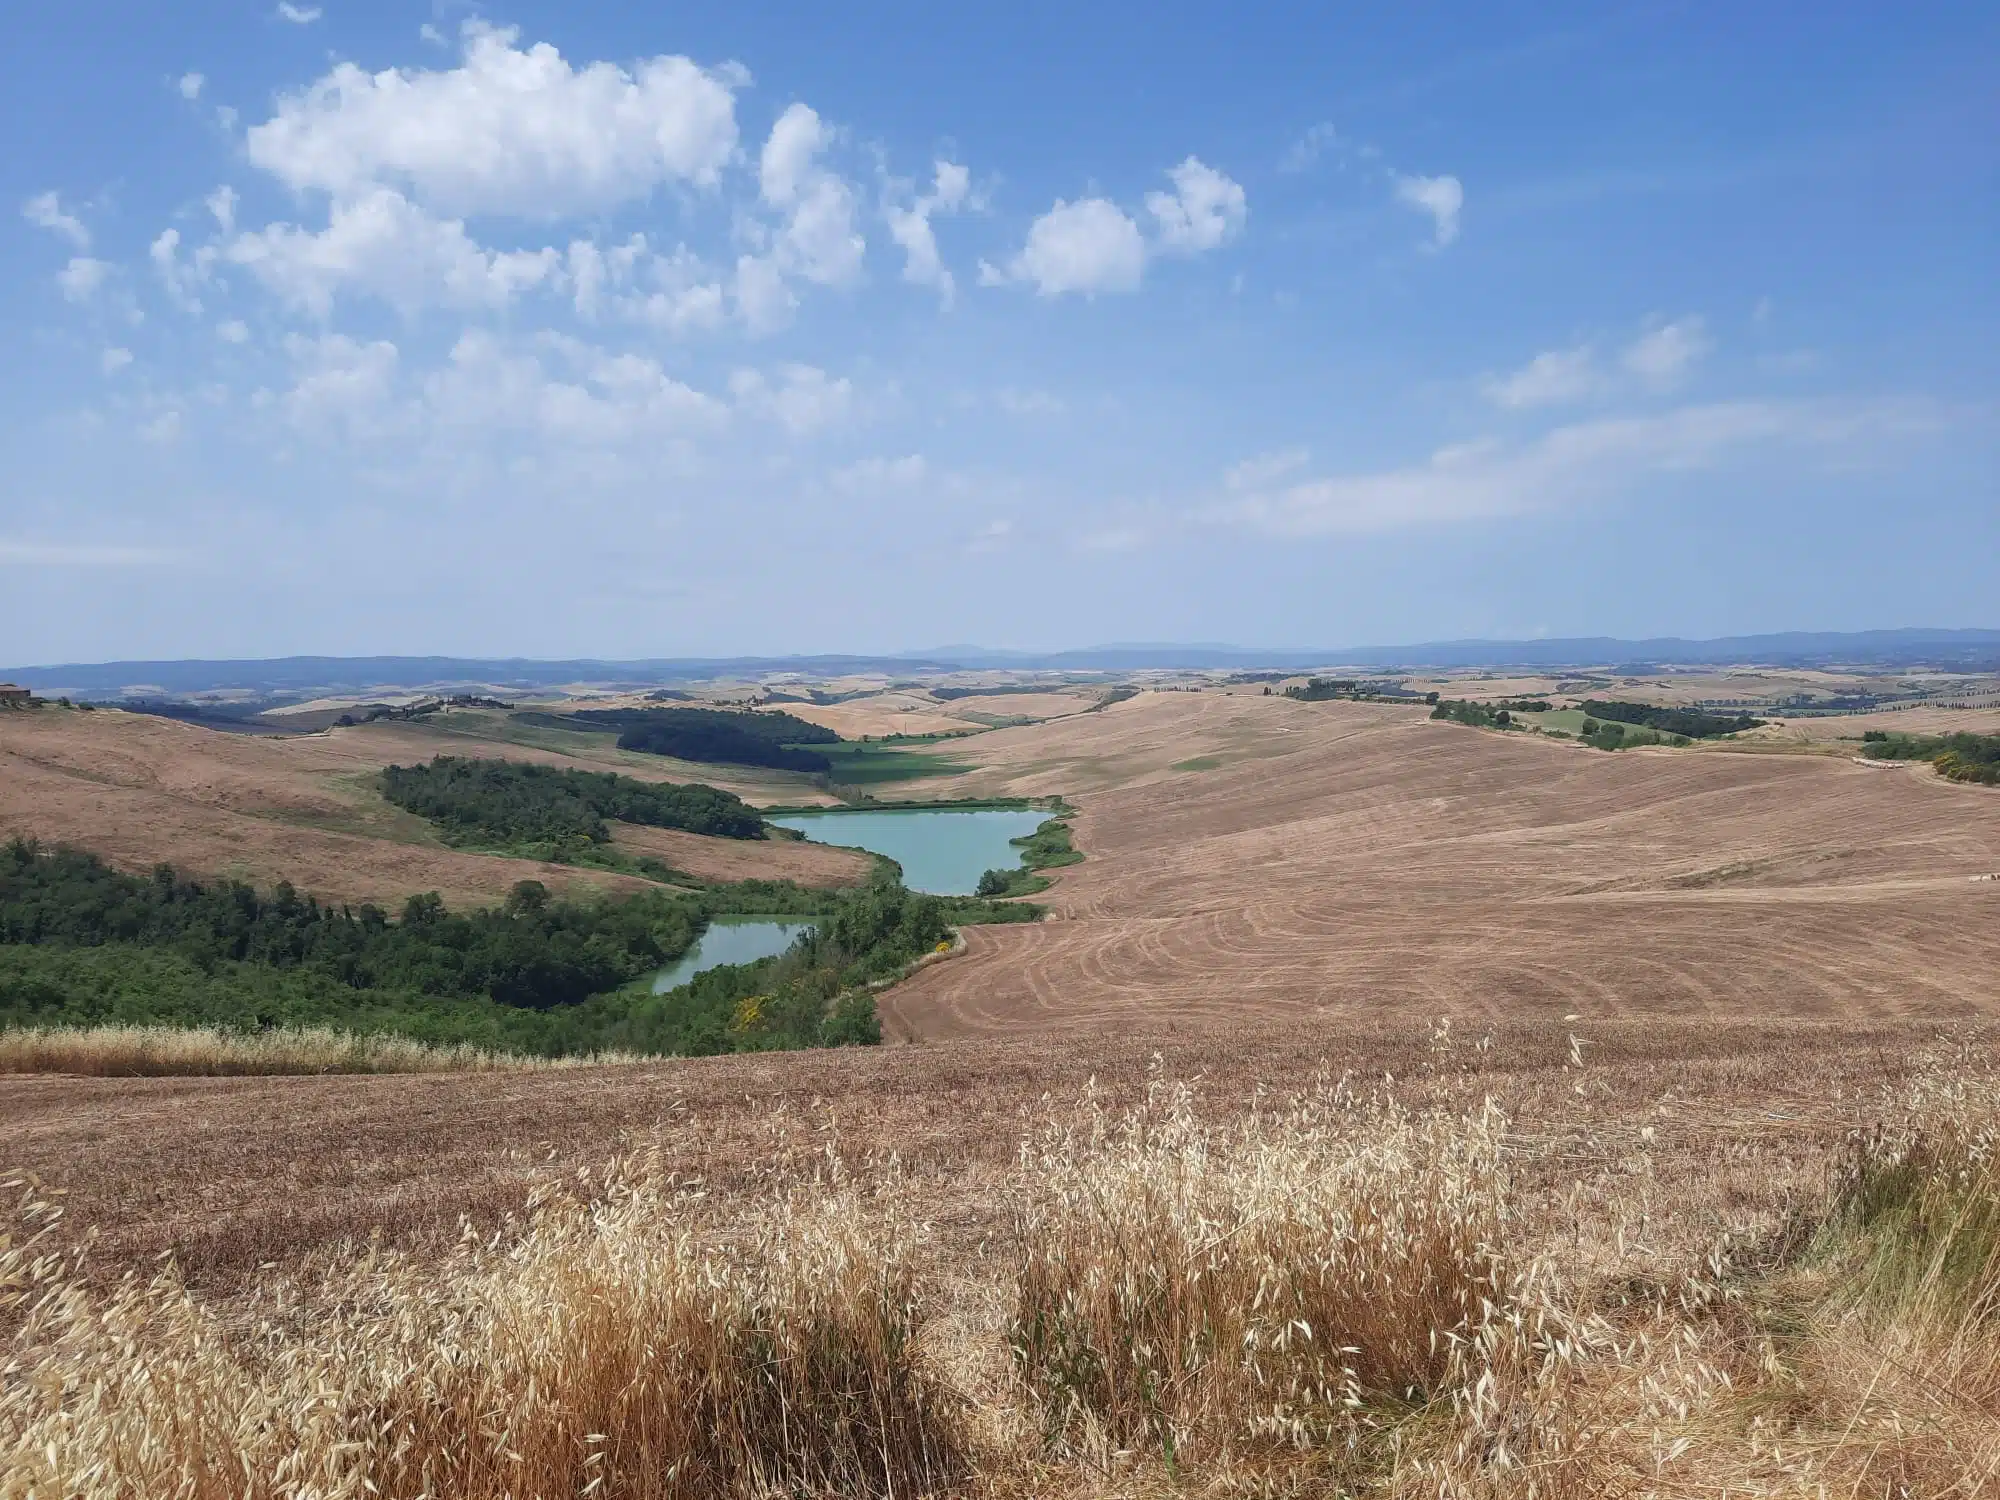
[{"x1": 0, "y1": 1016, "x2": 1968, "y2": 1292}]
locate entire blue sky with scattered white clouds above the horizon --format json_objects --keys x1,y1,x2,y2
[{"x1": 0, "y1": 0, "x2": 2000, "y2": 664}]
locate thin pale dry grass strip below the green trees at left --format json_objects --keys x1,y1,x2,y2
[{"x1": 0, "y1": 1026, "x2": 634, "y2": 1078}]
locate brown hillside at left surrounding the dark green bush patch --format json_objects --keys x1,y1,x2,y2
[{"x1": 0, "y1": 708, "x2": 852, "y2": 904}]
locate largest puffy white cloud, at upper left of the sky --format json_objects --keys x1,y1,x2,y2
[{"x1": 246, "y1": 22, "x2": 742, "y2": 218}]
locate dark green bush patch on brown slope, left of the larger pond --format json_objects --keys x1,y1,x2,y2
[{"x1": 382, "y1": 756, "x2": 764, "y2": 844}]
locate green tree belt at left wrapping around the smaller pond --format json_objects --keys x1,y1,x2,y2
[{"x1": 0, "y1": 840, "x2": 1040, "y2": 1056}]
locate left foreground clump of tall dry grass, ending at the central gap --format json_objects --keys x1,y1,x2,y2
[{"x1": 0, "y1": 1166, "x2": 960, "y2": 1500}]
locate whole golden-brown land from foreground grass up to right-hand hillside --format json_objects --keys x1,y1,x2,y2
[{"x1": 0, "y1": 692, "x2": 2000, "y2": 1500}]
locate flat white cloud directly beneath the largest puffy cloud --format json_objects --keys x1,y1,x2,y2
[{"x1": 226, "y1": 188, "x2": 562, "y2": 318}]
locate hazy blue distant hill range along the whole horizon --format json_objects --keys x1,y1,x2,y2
[{"x1": 0, "y1": 630, "x2": 2000, "y2": 698}]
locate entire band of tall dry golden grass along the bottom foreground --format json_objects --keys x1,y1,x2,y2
[{"x1": 11, "y1": 1028, "x2": 2000, "y2": 1500}]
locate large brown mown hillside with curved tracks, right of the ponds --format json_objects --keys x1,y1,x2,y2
[{"x1": 882, "y1": 694, "x2": 2000, "y2": 1038}]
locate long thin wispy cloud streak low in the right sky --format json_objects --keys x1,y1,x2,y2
[{"x1": 1210, "y1": 400, "x2": 1942, "y2": 536}]
